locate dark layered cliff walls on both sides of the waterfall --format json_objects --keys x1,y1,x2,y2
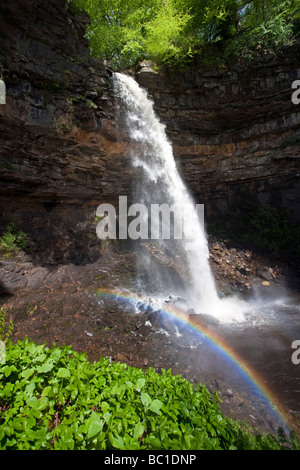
[{"x1": 0, "y1": 0, "x2": 300, "y2": 263}]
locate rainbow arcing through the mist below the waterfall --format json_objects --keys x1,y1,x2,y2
[{"x1": 96, "y1": 288, "x2": 293, "y2": 431}]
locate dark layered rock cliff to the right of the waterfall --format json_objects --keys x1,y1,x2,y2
[{"x1": 136, "y1": 51, "x2": 300, "y2": 224}]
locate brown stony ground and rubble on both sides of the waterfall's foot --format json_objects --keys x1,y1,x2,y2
[{"x1": 0, "y1": 238, "x2": 300, "y2": 438}]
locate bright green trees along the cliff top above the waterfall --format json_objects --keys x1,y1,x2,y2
[{"x1": 69, "y1": 0, "x2": 300, "y2": 67}]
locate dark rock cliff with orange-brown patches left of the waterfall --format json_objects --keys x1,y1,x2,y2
[{"x1": 0, "y1": 0, "x2": 130, "y2": 263}]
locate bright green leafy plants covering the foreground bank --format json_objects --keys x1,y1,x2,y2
[{"x1": 0, "y1": 339, "x2": 299, "y2": 450}]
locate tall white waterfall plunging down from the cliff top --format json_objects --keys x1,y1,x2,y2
[{"x1": 114, "y1": 73, "x2": 241, "y2": 320}]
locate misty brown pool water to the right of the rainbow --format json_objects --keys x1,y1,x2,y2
[{"x1": 218, "y1": 289, "x2": 300, "y2": 432}]
